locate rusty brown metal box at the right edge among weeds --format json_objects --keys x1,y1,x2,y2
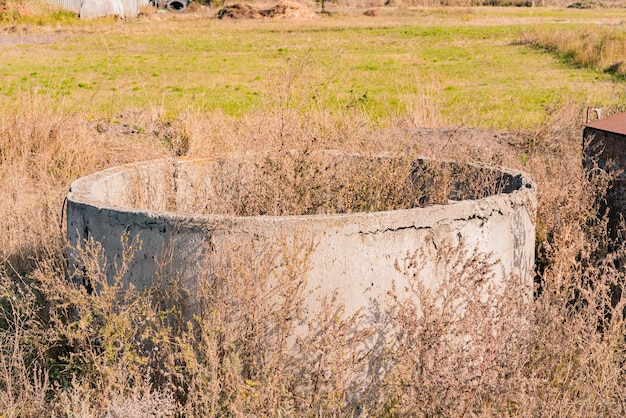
[{"x1": 583, "y1": 112, "x2": 626, "y2": 241}]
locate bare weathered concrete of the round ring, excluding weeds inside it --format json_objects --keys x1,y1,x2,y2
[{"x1": 67, "y1": 160, "x2": 536, "y2": 315}]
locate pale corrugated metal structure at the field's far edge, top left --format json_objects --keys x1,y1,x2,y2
[{"x1": 46, "y1": 0, "x2": 149, "y2": 19}]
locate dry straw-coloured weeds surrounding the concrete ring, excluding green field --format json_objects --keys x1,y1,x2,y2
[{"x1": 0, "y1": 48, "x2": 626, "y2": 417}]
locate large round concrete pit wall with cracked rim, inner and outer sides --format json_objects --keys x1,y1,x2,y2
[{"x1": 67, "y1": 154, "x2": 536, "y2": 322}]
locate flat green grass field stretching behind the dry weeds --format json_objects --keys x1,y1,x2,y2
[{"x1": 0, "y1": 8, "x2": 626, "y2": 129}]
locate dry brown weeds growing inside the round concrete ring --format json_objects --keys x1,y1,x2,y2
[{"x1": 124, "y1": 151, "x2": 516, "y2": 216}]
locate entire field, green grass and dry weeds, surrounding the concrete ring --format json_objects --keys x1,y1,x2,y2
[{"x1": 0, "y1": 7, "x2": 626, "y2": 417}]
